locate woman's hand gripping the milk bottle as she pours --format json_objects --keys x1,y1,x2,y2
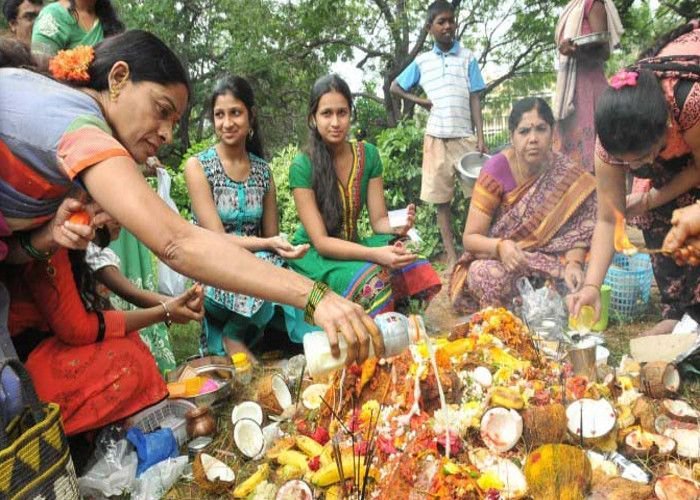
[{"x1": 314, "y1": 290, "x2": 384, "y2": 365}]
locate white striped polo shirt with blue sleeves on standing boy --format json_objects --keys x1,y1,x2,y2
[{"x1": 396, "y1": 41, "x2": 486, "y2": 139}]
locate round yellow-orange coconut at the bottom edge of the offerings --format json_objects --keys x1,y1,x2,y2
[{"x1": 525, "y1": 444, "x2": 593, "y2": 500}]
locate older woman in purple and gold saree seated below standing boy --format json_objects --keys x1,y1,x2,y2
[{"x1": 450, "y1": 98, "x2": 595, "y2": 312}]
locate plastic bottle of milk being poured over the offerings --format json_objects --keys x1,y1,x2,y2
[{"x1": 304, "y1": 312, "x2": 425, "y2": 377}]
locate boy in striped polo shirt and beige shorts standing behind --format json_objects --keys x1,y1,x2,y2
[{"x1": 391, "y1": 0, "x2": 486, "y2": 267}]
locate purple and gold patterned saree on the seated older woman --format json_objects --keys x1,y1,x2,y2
[{"x1": 449, "y1": 154, "x2": 596, "y2": 312}]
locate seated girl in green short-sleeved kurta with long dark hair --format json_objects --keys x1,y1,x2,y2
[{"x1": 289, "y1": 75, "x2": 441, "y2": 316}]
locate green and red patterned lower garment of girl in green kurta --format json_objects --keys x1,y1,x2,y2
[{"x1": 289, "y1": 234, "x2": 442, "y2": 317}]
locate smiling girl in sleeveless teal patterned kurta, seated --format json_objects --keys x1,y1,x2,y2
[{"x1": 185, "y1": 77, "x2": 312, "y2": 356}]
